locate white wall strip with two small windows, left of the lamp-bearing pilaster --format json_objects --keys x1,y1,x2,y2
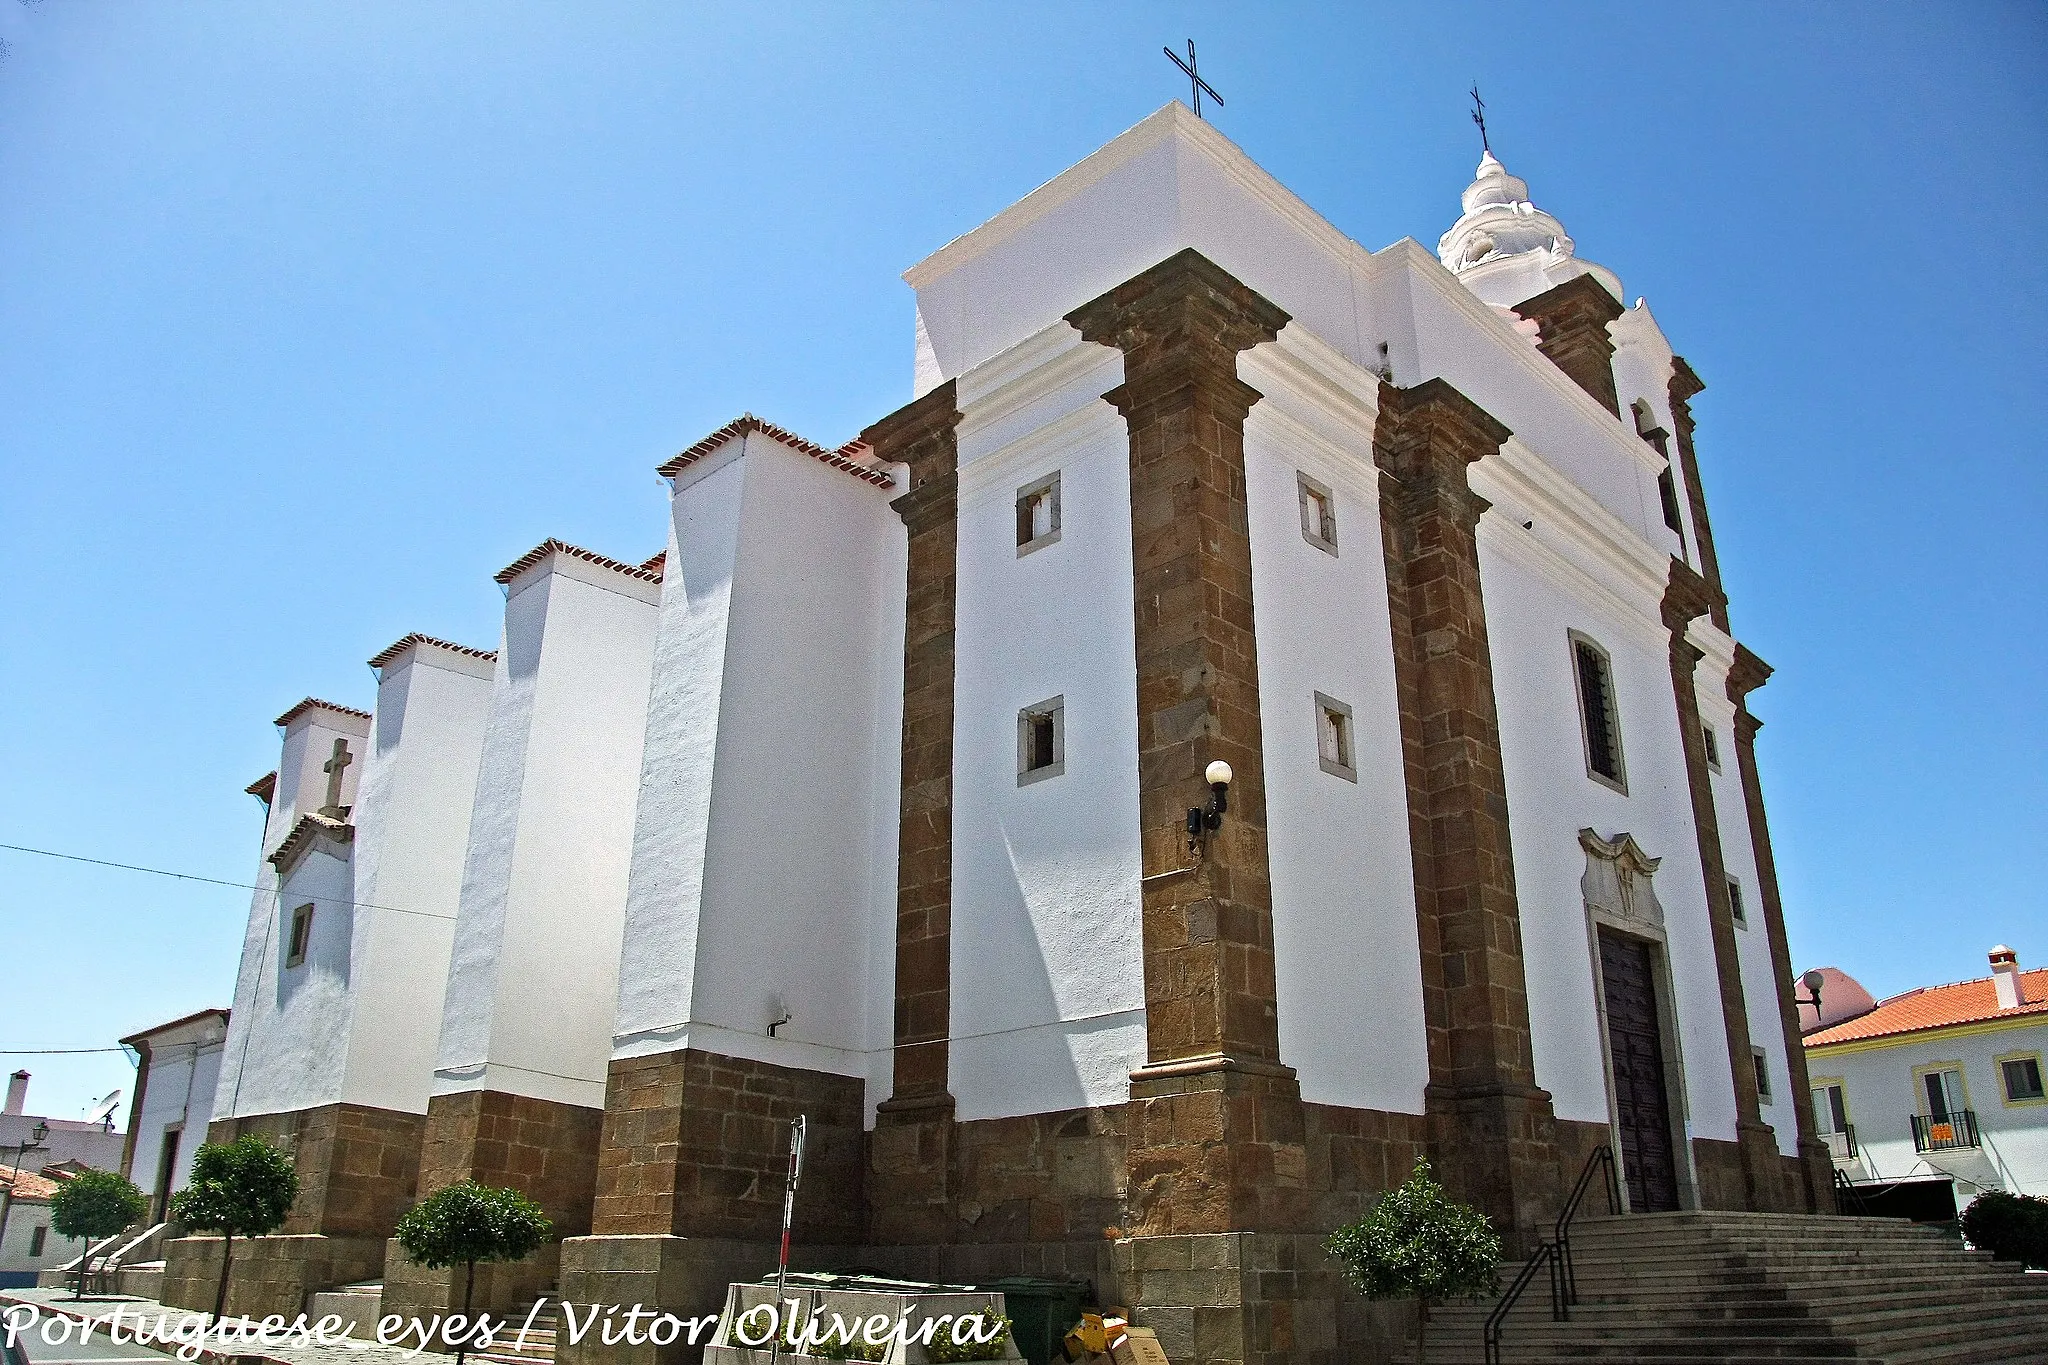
[{"x1": 948, "y1": 325, "x2": 1145, "y2": 1119}]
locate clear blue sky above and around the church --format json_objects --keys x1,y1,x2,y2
[{"x1": 0, "y1": 0, "x2": 2048, "y2": 1115}]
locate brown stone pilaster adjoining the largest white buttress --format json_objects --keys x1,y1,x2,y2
[{"x1": 860, "y1": 381, "x2": 961, "y2": 1242}]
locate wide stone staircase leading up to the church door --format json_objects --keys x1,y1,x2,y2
[{"x1": 1409, "y1": 1212, "x2": 2048, "y2": 1365}]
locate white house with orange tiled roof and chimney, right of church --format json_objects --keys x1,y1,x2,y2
[{"x1": 1802, "y1": 943, "x2": 2048, "y2": 1207}]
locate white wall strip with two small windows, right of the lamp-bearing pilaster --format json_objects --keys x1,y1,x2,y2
[{"x1": 1239, "y1": 335, "x2": 1430, "y2": 1113}]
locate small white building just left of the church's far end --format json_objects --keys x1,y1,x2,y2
[{"x1": 121, "y1": 1009, "x2": 227, "y2": 1222}]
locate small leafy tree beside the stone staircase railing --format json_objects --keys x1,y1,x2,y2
[{"x1": 1323, "y1": 1160, "x2": 1501, "y2": 1365}]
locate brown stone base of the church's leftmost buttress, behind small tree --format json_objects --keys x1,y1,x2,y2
[{"x1": 207, "y1": 1105, "x2": 426, "y2": 1236}]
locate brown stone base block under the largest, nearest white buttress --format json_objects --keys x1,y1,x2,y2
[{"x1": 590, "y1": 1048, "x2": 864, "y2": 1242}]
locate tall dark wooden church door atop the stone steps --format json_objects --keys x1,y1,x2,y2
[{"x1": 1599, "y1": 929, "x2": 1677, "y2": 1214}]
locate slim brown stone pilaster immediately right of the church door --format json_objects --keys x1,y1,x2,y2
[{"x1": 1663, "y1": 559, "x2": 1784, "y2": 1209}]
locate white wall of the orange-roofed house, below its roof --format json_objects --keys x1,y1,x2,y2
[{"x1": 1806, "y1": 1015, "x2": 2048, "y2": 1207}]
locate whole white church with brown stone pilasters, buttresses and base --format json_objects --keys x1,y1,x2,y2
[{"x1": 170, "y1": 104, "x2": 1833, "y2": 1361}]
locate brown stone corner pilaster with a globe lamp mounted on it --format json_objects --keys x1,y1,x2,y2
[{"x1": 1067, "y1": 250, "x2": 1307, "y2": 1236}]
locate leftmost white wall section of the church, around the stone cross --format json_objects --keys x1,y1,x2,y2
[{"x1": 213, "y1": 708, "x2": 371, "y2": 1117}]
